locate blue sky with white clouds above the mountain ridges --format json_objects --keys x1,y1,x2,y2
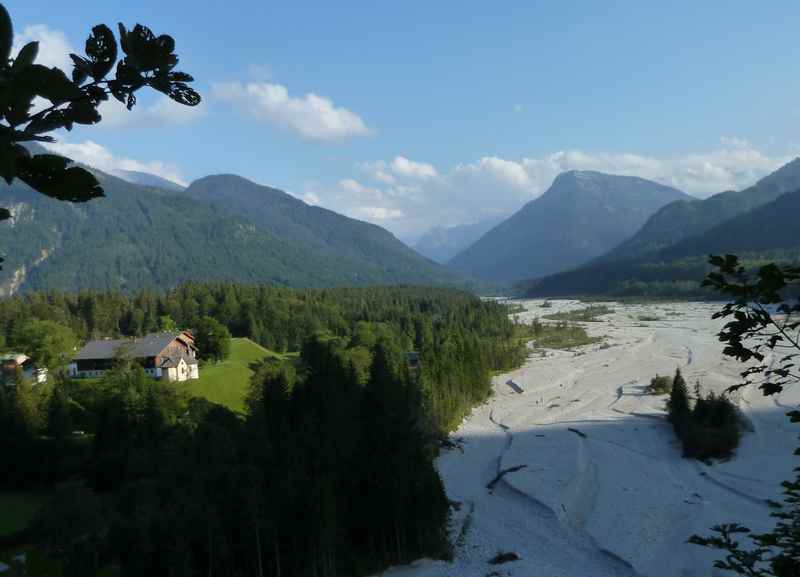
[{"x1": 5, "y1": 0, "x2": 800, "y2": 242}]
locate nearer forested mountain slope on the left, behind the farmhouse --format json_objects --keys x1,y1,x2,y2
[{"x1": 0, "y1": 172, "x2": 464, "y2": 294}]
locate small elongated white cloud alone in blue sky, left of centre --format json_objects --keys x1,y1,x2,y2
[{"x1": 212, "y1": 82, "x2": 371, "y2": 140}]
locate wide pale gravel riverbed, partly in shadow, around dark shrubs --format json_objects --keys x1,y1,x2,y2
[{"x1": 384, "y1": 301, "x2": 800, "y2": 577}]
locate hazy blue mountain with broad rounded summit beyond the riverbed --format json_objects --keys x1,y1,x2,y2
[{"x1": 449, "y1": 170, "x2": 690, "y2": 282}]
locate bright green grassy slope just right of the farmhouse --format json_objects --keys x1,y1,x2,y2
[{"x1": 186, "y1": 339, "x2": 297, "y2": 412}]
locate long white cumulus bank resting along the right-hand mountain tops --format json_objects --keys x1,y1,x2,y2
[{"x1": 302, "y1": 137, "x2": 794, "y2": 240}]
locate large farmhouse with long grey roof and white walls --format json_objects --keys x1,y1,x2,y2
[{"x1": 69, "y1": 331, "x2": 200, "y2": 381}]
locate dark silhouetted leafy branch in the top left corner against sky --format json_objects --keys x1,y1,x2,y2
[{"x1": 0, "y1": 4, "x2": 200, "y2": 226}]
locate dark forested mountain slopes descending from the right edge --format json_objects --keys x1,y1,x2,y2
[{"x1": 523, "y1": 159, "x2": 800, "y2": 296}]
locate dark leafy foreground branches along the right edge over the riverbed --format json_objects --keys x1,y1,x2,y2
[{"x1": 689, "y1": 255, "x2": 800, "y2": 577}]
